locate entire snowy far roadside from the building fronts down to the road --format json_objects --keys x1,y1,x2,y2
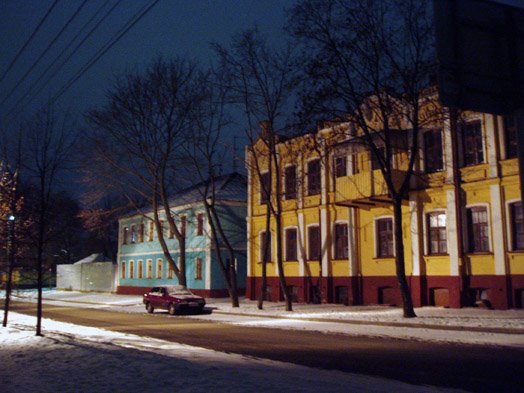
[{"x1": 7, "y1": 290, "x2": 524, "y2": 348}]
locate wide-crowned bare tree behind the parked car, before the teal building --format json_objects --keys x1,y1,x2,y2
[{"x1": 84, "y1": 59, "x2": 202, "y2": 285}]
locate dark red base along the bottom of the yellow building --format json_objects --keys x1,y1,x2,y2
[{"x1": 246, "y1": 275, "x2": 524, "y2": 310}]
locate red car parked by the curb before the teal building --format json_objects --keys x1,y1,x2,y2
[{"x1": 143, "y1": 285, "x2": 206, "y2": 315}]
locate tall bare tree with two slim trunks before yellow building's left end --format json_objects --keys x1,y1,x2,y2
[{"x1": 213, "y1": 29, "x2": 296, "y2": 311}]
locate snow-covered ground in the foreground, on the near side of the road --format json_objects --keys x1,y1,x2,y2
[{"x1": 0, "y1": 313, "x2": 457, "y2": 393}]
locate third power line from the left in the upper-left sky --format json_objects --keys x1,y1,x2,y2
[{"x1": 8, "y1": 0, "x2": 122, "y2": 116}]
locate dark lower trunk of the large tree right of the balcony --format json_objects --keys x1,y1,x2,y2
[{"x1": 393, "y1": 197, "x2": 417, "y2": 318}]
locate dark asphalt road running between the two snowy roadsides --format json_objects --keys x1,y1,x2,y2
[{"x1": 8, "y1": 303, "x2": 524, "y2": 392}]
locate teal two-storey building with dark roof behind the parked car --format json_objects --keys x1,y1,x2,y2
[{"x1": 117, "y1": 173, "x2": 247, "y2": 297}]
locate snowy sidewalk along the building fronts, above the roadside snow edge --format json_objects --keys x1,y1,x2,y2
[{"x1": 8, "y1": 290, "x2": 524, "y2": 336}]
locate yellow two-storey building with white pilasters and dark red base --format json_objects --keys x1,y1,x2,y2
[{"x1": 246, "y1": 108, "x2": 524, "y2": 309}]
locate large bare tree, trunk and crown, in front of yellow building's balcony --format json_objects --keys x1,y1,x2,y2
[{"x1": 289, "y1": 0, "x2": 441, "y2": 317}]
